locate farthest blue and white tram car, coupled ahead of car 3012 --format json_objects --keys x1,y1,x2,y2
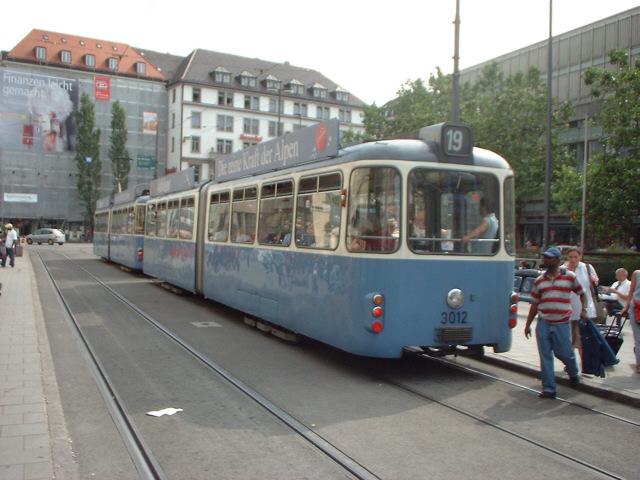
[{"x1": 93, "y1": 189, "x2": 149, "y2": 270}]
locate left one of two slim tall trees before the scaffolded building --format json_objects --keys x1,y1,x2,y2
[{"x1": 75, "y1": 93, "x2": 102, "y2": 237}]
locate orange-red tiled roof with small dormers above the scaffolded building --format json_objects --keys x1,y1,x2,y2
[{"x1": 7, "y1": 29, "x2": 168, "y2": 80}]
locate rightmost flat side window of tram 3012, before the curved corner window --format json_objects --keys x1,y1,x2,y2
[{"x1": 295, "y1": 173, "x2": 342, "y2": 250}]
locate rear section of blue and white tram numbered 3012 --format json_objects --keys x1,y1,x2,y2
[{"x1": 196, "y1": 122, "x2": 516, "y2": 358}]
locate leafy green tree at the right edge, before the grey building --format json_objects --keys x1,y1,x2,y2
[{"x1": 554, "y1": 50, "x2": 640, "y2": 241}]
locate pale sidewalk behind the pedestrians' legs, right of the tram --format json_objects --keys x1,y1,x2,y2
[{"x1": 486, "y1": 302, "x2": 640, "y2": 406}]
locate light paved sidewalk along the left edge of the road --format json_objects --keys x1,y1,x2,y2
[{"x1": 0, "y1": 249, "x2": 69, "y2": 480}]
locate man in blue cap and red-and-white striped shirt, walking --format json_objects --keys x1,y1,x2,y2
[{"x1": 524, "y1": 247, "x2": 587, "y2": 398}]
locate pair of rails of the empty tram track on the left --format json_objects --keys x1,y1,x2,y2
[{"x1": 38, "y1": 252, "x2": 380, "y2": 480}]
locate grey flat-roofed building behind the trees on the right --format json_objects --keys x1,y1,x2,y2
[{"x1": 460, "y1": 7, "x2": 640, "y2": 248}]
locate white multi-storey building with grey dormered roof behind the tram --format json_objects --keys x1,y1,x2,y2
[{"x1": 167, "y1": 49, "x2": 365, "y2": 178}]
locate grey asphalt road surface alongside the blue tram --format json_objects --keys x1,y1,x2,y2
[{"x1": 36, "y1": 245, "x2": 640, "y2": 479}]
